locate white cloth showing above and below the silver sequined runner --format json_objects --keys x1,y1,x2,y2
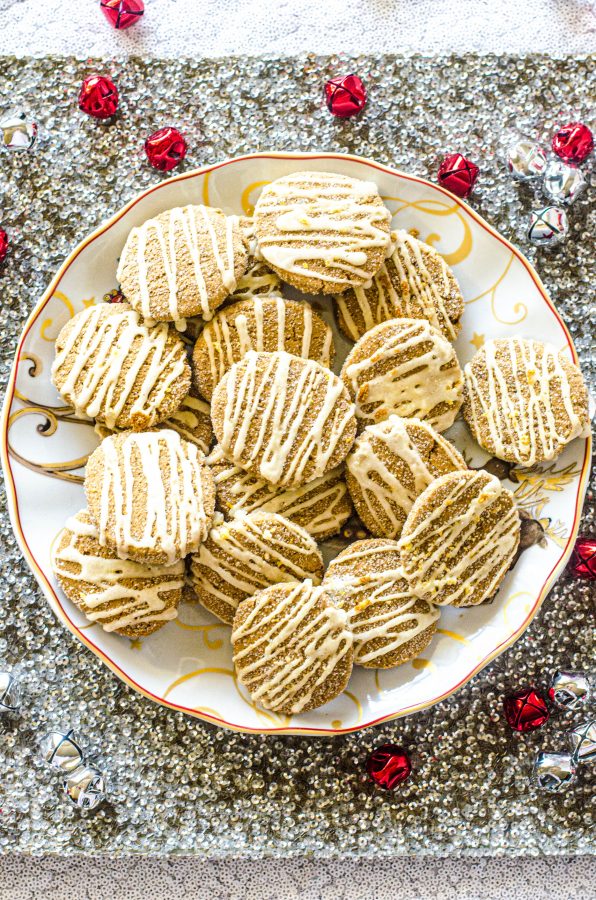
[{"x1": 0, "y1": 0, "x2": 596, "y2": 900}]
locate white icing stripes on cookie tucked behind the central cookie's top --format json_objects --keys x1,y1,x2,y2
[{"x1": 199, "y1": 296, "x2": 333, "y2": 392}]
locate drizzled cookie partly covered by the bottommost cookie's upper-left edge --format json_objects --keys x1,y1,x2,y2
[{"x1": 190, "y1": 511, "x2": 323, "y2": 624}]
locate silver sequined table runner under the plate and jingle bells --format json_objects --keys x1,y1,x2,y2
[{"x1": 0, "y1": 55, "x2": 596, "y2": 857}]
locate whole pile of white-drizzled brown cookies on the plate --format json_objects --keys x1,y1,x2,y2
[{"x1": 52, "y1": 172, "x2": 588, "y2": 715}]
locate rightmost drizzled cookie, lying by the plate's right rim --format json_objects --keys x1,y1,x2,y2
[{"x1": 463, "y1": 338, "x2": 590, "y2": 466}]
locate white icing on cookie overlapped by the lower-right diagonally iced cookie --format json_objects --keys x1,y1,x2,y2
[{"x1": 346, "y1": 415, "x2": 467, "y2": 538}]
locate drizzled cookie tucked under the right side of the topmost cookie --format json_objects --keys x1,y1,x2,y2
[{"x1": 334, "y1": 231, "x2": 464, "y2": 341}]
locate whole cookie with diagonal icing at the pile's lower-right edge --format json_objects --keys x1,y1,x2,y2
[{"x1": 399, "y1": 471, "x2": 521, "y2": 606}]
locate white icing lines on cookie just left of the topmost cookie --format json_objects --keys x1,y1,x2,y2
[{"x1": 116, "y1": 206, "x2": 238, "y2": 331}]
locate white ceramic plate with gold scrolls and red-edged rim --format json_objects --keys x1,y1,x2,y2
[{"x1": 2, "y1": 153, "x2": 590, "y2": 734}]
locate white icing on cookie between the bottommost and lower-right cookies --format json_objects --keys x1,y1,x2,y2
[{"x1": 323, "y1": 541, "x2": 440, "y2": 666}]
